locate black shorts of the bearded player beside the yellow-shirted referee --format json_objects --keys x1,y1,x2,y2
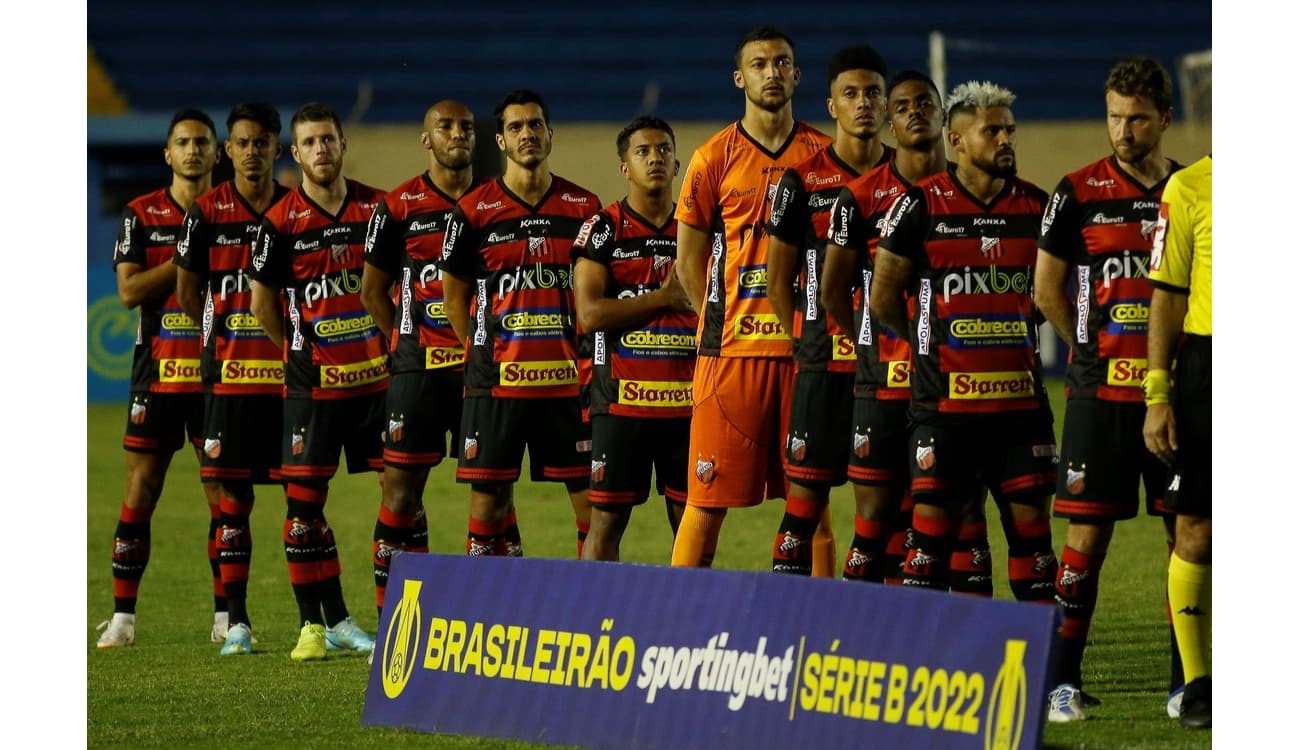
[{"x1": 1052, "y1": 399, "x2": 1169, "y2": 521}]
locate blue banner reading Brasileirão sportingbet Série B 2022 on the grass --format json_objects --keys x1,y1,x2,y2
[{"x1": 361, "y1": 554, "x2": 1060, "y2": 750}]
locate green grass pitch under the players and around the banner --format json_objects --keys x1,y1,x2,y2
[{"x1": 86, "y1": 386, "x2": 1210, "y2": 750}]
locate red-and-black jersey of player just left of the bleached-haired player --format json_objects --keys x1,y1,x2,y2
[{"x1": 828, "y1": 160, "x2": 935, "y2": 400}]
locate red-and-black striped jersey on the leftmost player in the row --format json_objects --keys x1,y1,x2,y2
[{"x1": 113, "y1": 187, "x2": 203, "y2": 394}]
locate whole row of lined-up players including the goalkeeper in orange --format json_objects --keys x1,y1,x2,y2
[{"x1": 99, "y1": 27, "x2": 1209, "y2": 727}]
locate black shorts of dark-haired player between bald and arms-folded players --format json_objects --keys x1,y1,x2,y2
[{"x1": 456, "y1": 396, "x2": 592, "y2": 484}]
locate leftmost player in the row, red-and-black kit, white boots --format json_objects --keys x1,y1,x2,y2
[{"x1": 95, "y1": 109, "x2": 228, "y2": 649}]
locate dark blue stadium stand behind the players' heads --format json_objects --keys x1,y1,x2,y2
[{"x1": 87, "y1": 0, "x2": 1212, "y2": 122}]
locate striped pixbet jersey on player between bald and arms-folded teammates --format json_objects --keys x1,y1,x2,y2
[{"x1": 438, "y1": 175, "x2": 601, "y2": 398}]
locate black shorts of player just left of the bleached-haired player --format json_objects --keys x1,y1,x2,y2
[{"x1": 849, "y1": 399, "x2": 911, "y2": 487}]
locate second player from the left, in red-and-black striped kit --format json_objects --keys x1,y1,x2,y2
[{"x1": 173, "y1": 103, "x2": 289, "y2": 655}]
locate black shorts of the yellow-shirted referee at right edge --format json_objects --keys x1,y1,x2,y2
[{"x1": 1165, "y1": 334, "x2": 1214, "y2": 519}]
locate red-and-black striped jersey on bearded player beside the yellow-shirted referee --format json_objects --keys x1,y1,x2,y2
[{"x1": 1039, "y1": 156, "x2": 1182, "y2": 403}]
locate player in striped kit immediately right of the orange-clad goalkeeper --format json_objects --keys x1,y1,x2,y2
[{"x1": 767, "y1": 47, "x2": 893, "y2": 576}]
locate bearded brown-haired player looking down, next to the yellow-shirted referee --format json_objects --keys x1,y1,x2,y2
[{"x1": 1034, "y1": 57, "x2": 1183, "y2": 721}]
